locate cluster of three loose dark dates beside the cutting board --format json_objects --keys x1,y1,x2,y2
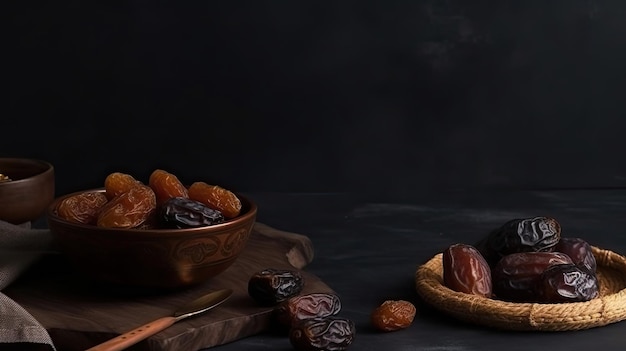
[{"x1": 248, "y1": 268, "x2": 356, "y2": 351}]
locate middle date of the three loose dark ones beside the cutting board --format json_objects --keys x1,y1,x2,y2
[{"x1": 274, "y1": 293, "x2": 341, "y2": 328}]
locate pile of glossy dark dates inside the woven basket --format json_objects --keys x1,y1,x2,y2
[{"x1": 442, "y1": 217, "x2": 599, "y2": 303}]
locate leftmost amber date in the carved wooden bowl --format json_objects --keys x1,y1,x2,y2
[{"x1": 57, "y1": 191, "x2": 108, "y2": 225}]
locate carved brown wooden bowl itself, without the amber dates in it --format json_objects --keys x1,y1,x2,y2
[{"x1": 47, "y1": 189, "x2": 257, "y2": 289}]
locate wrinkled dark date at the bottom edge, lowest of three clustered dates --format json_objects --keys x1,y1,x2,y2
[{"x1": 289, "y1": 317, "x2": 356, "y2": 351}]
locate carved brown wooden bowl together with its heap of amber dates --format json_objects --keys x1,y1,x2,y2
[{"x1": 47, "y1": 170, "x2": 257, "y2": 289}]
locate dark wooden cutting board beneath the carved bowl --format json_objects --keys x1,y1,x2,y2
[{"x1": 3, "y1": 223, "x2": 333, "y2": 351}]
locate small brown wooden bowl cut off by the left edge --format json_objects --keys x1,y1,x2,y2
[{"x1": 0, "y1": 158, "x2": 55, "y2": 224}]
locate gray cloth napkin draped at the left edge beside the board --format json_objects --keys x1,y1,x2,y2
[{"x1": 0, "y1": 220, "x2": 56, "y2": 350}]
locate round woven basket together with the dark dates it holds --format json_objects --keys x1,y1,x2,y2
[{"x1": 415, "y1": 216, "x2": 626, "y2": 331}]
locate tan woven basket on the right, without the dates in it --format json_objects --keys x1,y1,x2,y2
[{"x1": 415, "y1": 246, "x2": 626, "y2": 331}]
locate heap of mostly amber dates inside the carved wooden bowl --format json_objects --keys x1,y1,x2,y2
[{"x1": 57, "y1": 169, "x2": 242, "y2": 229}]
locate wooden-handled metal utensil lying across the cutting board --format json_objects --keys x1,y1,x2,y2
[{"x1": 87, "y1": 289, "x2": 233, "y2": 351}]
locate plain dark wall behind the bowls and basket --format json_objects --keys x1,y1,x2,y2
[{"x1": 0, "y1": 0, "x2": 626, "y2": 199}]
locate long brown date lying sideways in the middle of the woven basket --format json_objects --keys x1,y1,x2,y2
[{"x1": 492, "y1": 252, "x2": 572, "y2": 302}]
